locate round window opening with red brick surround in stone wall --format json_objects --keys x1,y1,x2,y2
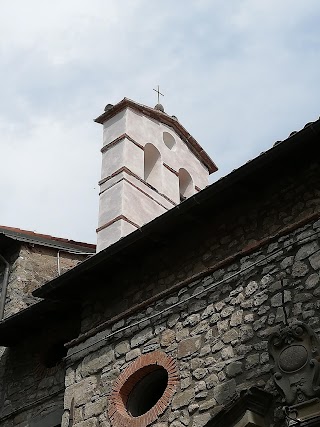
[{"x1": 108, "y1": 351, "x2": 179, "y2": 427}]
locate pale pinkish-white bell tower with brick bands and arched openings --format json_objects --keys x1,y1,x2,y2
[{"x1": 95, "y1": 98, "x2": 217, "y2": 252}]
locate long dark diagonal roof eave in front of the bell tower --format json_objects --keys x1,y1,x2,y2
[{"x1": 33, "y1": 120, "x2": 320, "y2": 299}]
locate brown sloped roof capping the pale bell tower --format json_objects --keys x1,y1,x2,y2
[{"x1": 94, "y1": 98, "x2": 218, "y2": 173}]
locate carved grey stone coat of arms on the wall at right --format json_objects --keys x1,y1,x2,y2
[{"x1": 269, "y1": 322, "x2": 320, "y2": 405}]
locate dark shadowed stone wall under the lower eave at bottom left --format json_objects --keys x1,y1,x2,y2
[{"x1": 0, "y1": 304, "x2": 80, "y2": 427}]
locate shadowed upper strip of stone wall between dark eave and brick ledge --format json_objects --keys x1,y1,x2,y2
[{"x1": 82, "y1": 162, "x2": 320, "y2": 332}]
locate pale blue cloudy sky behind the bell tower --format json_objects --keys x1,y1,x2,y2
[{"x1": 0, "y1": 0, "x2": 320, "y2": 243}]
